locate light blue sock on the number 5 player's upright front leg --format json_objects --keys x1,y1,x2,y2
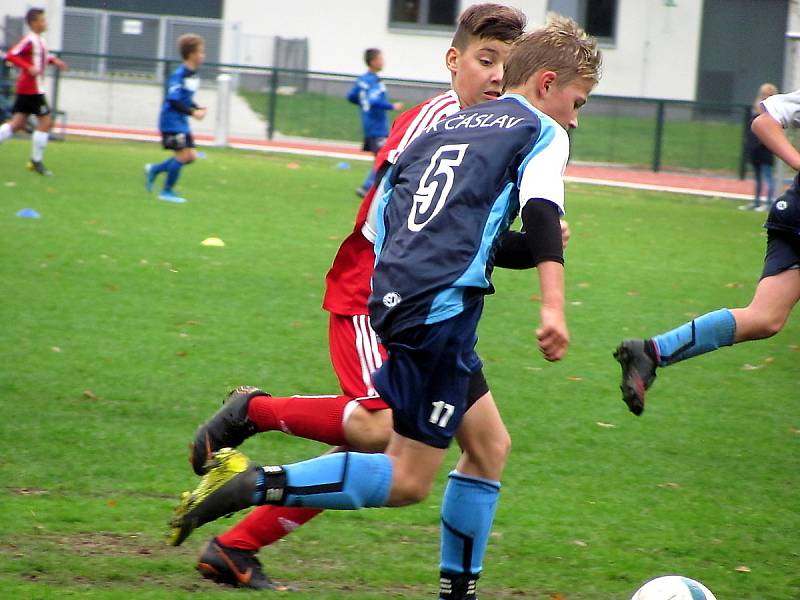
[{"x1": 440, "y1": 471, "x2": 500, "y2": 574}]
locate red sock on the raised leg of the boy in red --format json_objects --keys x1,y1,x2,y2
[{"x1": 247, "y1": 396, "x2": 352, "y2": 446}]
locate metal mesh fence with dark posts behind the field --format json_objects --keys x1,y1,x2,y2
[{"x1": 0, "y1": 52, "x2": 749, "y2": 177}]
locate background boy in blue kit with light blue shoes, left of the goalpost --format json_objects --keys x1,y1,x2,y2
[{"x1": 144, "y1": 33, "x2": 206, "y2": 204}]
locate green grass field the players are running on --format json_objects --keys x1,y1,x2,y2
[{"x1": 0, "y1": 139, "x2": 800, "y2": 600}]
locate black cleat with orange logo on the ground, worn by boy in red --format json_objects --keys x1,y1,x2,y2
[{"x1": 197, "y1": 538, "x2": 292, "y2": 592}]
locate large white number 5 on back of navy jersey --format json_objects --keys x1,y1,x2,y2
[{"x1": 408, "y1": 144, "x2": 469, "y2": 231}]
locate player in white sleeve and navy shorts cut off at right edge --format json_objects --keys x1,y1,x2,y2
[{"x1": 614, "y1": 90, "x2": 800, "y2": 415}]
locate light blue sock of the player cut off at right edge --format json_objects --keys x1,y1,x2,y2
[{"x1": 653, "y1": 308, "x2": 736, "y2": 367}]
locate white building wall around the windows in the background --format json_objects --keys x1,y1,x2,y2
[{"x1": 225, "y1": 0, "x2": 702, "y2": 100}]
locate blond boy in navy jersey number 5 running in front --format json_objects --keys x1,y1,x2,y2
[{"x1": 171, "y1": 17, "x2": 600, "y2": 600}]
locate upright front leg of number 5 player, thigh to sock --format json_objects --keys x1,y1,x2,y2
[{"x1": 439, "y1": 392, "x2": 511, "y2": 600}]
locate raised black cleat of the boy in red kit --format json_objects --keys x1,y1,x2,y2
[{"x1": 189, "y1": 385, "x2": 269, "y2": 475}]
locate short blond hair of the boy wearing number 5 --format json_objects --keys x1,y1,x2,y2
[{"x1": 503, "y1": 13, "x2": 603, "y2": 90}]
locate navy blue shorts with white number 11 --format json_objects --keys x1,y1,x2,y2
[{"x1": 372, "y1": 302, "x2": 488, "y2": 448}]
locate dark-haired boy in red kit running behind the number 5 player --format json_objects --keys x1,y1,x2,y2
[{"x1": 192, "y1": 4, "x2": 536, "y2": 590}]
